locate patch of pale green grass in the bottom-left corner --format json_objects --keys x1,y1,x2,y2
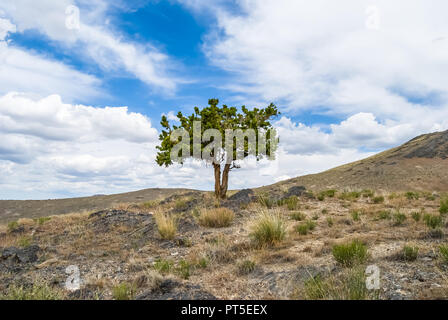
[{"x1": 0, "y1": 281, "x2": 63, "y2": 300}]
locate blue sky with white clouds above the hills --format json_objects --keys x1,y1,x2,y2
[{"x1": 0, "y1": 0, "x2": 448, "y2": 199}]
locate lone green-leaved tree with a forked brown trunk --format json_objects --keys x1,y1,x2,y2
[{"x1": 156, "y1": 99, "x2": 280, "y2": 199}]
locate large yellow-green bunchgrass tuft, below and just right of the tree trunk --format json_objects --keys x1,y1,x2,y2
[{"x1": 250, "y1": 212, "x2": 286, "y2": 246}]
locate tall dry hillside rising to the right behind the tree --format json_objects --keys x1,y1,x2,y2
[{"x1": 264, "y1": 131, "x2": 448, "y2": 191}]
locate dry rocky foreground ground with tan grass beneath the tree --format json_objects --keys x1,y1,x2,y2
[{"x1": 0, "y1": 186, "x2": 448, "y2": 299}]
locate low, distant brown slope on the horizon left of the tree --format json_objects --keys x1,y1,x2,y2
[{"x1": 0, "y1": 188, "x2": 198, "y2": 223}]
